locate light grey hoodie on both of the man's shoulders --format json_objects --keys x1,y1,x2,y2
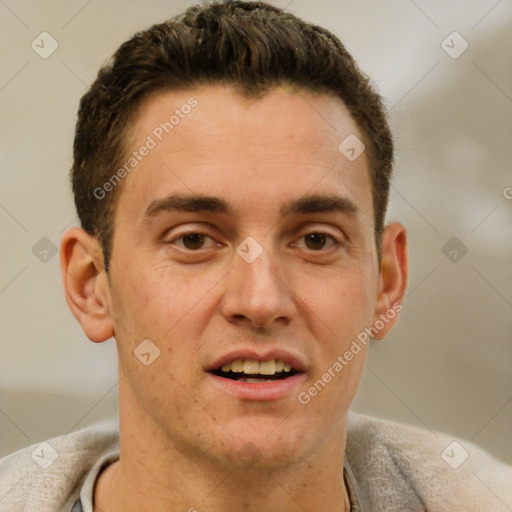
[{"x1": 0, "y1": 413, "x2": 512, "y2": 512}]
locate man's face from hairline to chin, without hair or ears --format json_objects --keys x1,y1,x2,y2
[{"x1": 108, "y1": 87, "x2": 379, "y2": 466}]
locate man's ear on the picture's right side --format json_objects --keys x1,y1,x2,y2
[{"x1": 372, "y1": 222, "x2": 409, "y2": 340}]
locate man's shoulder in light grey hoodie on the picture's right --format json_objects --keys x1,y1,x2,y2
[{"x1": 346, "y1": 413, "x2": 512, "y2": 512}]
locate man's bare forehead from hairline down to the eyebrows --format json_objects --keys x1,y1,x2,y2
[{"x1": 119, "y1": 86, "x2": 371, "y2": 224}]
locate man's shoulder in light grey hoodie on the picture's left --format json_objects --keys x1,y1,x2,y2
[{"x1": 0, "y1": 422, "x2": 119, "y2": 512}]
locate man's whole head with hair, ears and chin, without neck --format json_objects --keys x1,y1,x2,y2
[{"x1": 61, "y1": 2, "x2": 407, "y2": 467}]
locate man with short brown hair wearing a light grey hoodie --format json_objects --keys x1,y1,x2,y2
[{"x1": 0, "y1": 2, "x2": 512, "y2": 512}]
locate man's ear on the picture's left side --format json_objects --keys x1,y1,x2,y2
[{"x1": 60, "y1": 228, "x2": 114, "y2": 343}]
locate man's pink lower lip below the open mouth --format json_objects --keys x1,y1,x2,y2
[{"x1": 208, "y1": 373, "x2": 305, "y2": 402}]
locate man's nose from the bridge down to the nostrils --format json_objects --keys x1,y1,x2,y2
[{"x1": 220, "y1": 242, "x2": 296, "y2": 328}]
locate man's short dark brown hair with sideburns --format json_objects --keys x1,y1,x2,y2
[{"x1": 71, "y1": 1, "x2": 393, "y2": 269}]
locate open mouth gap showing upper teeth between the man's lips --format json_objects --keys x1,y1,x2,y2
[{"x1": 211, "y1": 359, "x2": 298, "y2": 384}]
